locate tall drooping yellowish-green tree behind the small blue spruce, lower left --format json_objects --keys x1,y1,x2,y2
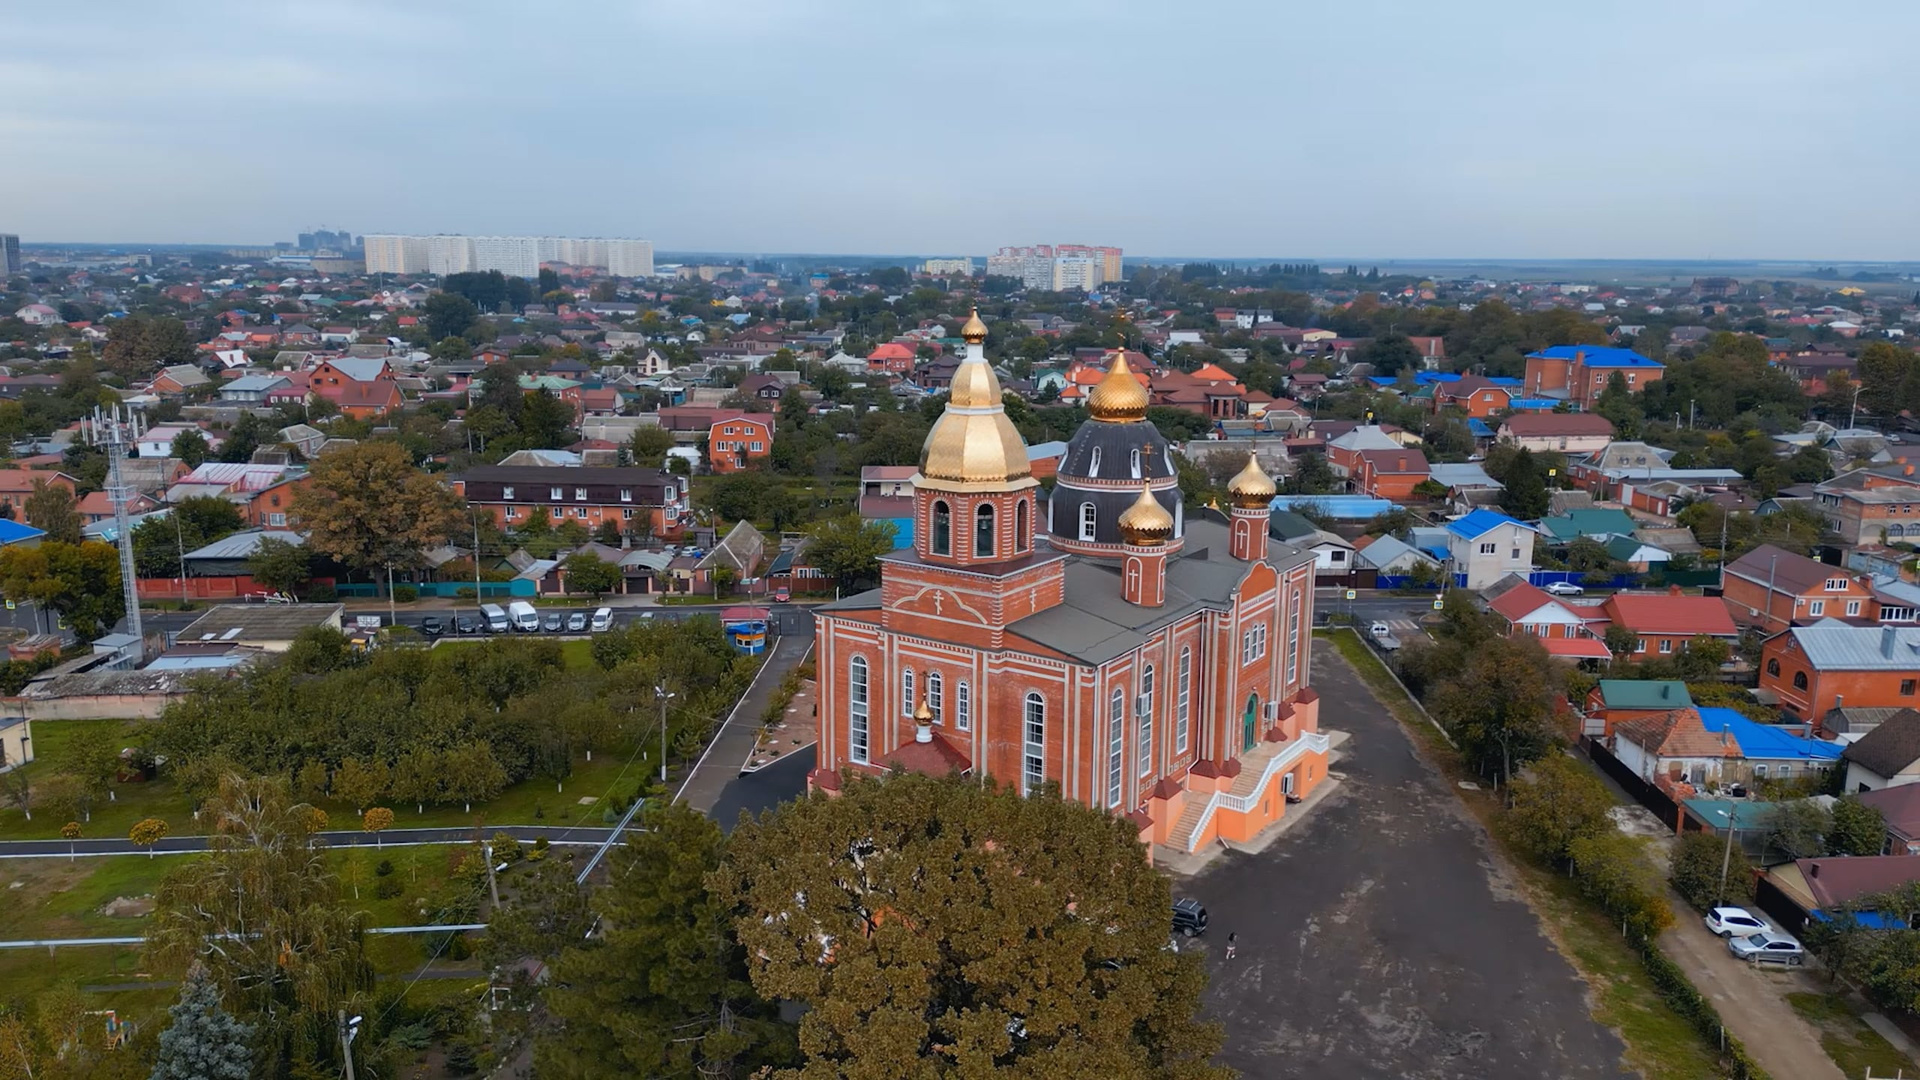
[{"x1": 146, "y1": 774, "x2": 372, "y2": 1076}]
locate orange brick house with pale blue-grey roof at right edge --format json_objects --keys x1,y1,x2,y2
[{"x1": 1759, "y1": 619, "x2": 1920, "y2": 730}]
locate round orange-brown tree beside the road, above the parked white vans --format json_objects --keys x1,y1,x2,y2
[{"x1": 292, "y1": 440, "x2": 461, "y2": 571}]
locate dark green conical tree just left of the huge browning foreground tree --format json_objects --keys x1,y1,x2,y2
[{"x1": 537, "y1": 803, "x2": 793, "y2": 1080}]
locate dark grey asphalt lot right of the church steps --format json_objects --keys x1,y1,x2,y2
[{"x1": 1175, "y1": 648, "x2": 1634, "y2": 1080}]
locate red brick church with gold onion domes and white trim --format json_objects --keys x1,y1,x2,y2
[{"x1": 810, "y1": 315, "x2": 1327, "y2": 851}]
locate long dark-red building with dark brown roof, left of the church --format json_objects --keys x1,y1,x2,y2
[{"x1": 453, "y1": 465, "x2": 687, "y2": 540}]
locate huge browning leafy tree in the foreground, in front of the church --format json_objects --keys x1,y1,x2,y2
[{"x1": 714, "y1": 774, "x2": 1229, "y2": 1080}]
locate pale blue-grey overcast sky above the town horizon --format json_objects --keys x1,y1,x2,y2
[{"x1": 0, "y1": 0, "x2": 1920, "y2": 259}]
